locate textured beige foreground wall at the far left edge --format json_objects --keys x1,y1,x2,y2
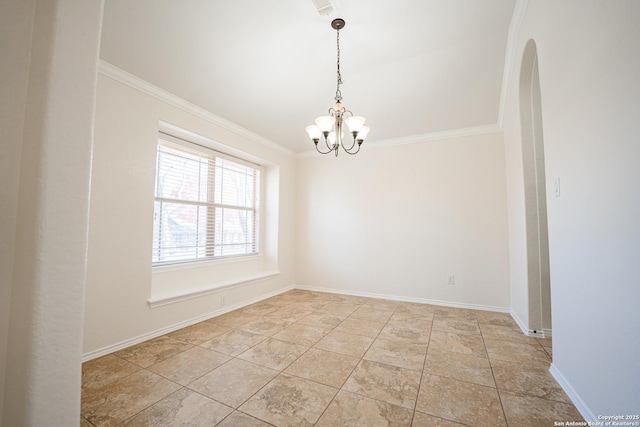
[{"x1": 0, "y1": 0, "x2": 102, "y2": 426}]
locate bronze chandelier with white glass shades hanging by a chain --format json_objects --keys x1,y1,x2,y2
[{"x1": 305, "y1": 18, "x2": 370, "y2": 157}]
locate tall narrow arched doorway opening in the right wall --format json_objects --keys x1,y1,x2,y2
[{"x1": 520, "y1": 40, "x2": 551, "y2": 336}]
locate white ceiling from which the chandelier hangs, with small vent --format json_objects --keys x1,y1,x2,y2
[{"x1": 100, "y1": 0, "x2": 515, "y2": 152}]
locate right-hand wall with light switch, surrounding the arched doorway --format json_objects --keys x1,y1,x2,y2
[{"x1": 504, "y1": 0, "x2": 640, "y2": 421}]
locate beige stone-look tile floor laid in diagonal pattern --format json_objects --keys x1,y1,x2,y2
[{"x1": 80, "y1": 290, "x2": 582, "y2": 427}]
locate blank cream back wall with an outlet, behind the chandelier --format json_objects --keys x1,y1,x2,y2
[{"x1": 296, "y1": 131, "x2": 509, "y2": 310}]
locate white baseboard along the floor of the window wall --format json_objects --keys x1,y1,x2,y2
[{"x1": 82, "y1": 286, "x2": 294, "y2": 363}]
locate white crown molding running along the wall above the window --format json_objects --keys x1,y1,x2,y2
[{"x1": 98, "y1": 59, "x2": 295, "y2": 156}]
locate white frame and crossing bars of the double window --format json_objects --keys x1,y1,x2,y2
[{"x1": 151, "y1": 129, "x2": 264, "y2": 270}]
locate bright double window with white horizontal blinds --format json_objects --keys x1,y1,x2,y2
[{"x1": 152, "y1": 133, "x2": 260, "y2": 266}]
